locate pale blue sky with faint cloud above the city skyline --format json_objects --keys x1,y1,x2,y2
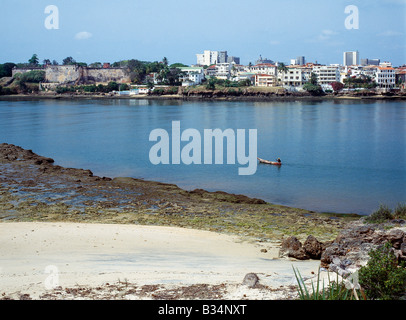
[{"x1": 0, "y1": 0, "x2": 406, "y2": 66}]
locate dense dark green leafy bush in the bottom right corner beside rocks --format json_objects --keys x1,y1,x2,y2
[{"x1": 359, "y1": 243, "x2": 406, "y2": 300}]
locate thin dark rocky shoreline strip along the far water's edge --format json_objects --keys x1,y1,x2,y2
[{"x1": 0, "y1": 94, "x2": 406, "y2": 102}]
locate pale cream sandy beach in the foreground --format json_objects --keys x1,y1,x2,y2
[{"x1": 0, "y1": 222, "x2": 320, "y2": 299}]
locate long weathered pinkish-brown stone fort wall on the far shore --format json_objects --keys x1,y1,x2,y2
[{"x1": 45, "y1": 65, "x2": 131, "y2": 85}]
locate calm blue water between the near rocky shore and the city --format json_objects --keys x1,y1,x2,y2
[{"x1": 0, "y1": 100, "x2": 406, "y2": 214}]
